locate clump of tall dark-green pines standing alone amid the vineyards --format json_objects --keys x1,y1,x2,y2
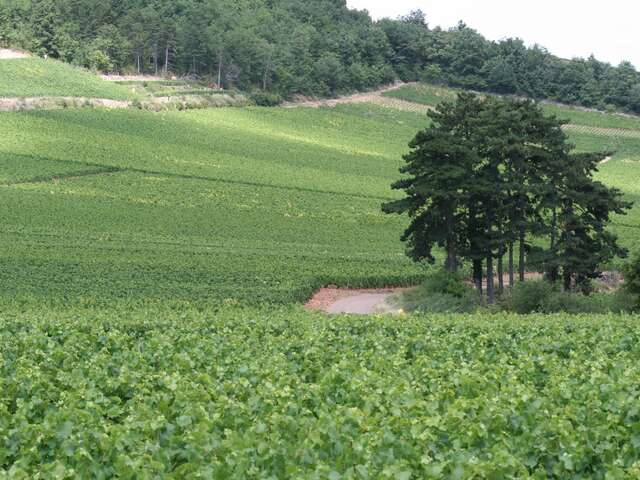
[{"x1": 382, "y1": 93, "x2": 631, "y2": 303}]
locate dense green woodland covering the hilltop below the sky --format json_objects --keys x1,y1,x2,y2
[{"x1": 0, "y1": 0, "x2": 640, "y2": 113}]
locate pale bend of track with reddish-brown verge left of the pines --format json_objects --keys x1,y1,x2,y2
[{"x1": 305, "y1": 287, "x2": 409, "y2": 315}]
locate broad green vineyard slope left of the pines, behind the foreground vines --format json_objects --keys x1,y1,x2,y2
[{"x1": 0, "y1": 106, "x2": 424, "y2": 304}]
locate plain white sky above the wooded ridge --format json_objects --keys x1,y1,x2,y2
[{"x1": 347, "y1": 0, "x2": 640, "y2": 68}]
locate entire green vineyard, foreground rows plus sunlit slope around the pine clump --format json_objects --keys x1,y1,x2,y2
[{"x1": 0, "y1": 79, "x2": 640, "y2": 480}]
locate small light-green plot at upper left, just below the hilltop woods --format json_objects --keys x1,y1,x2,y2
[{"x1": 0, "y1": 57, "x2": 138, "y2": 100}]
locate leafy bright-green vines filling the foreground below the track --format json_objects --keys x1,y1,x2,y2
[{"x1": 0, "y1": 305, "x2": 640, "y2": 479}]
